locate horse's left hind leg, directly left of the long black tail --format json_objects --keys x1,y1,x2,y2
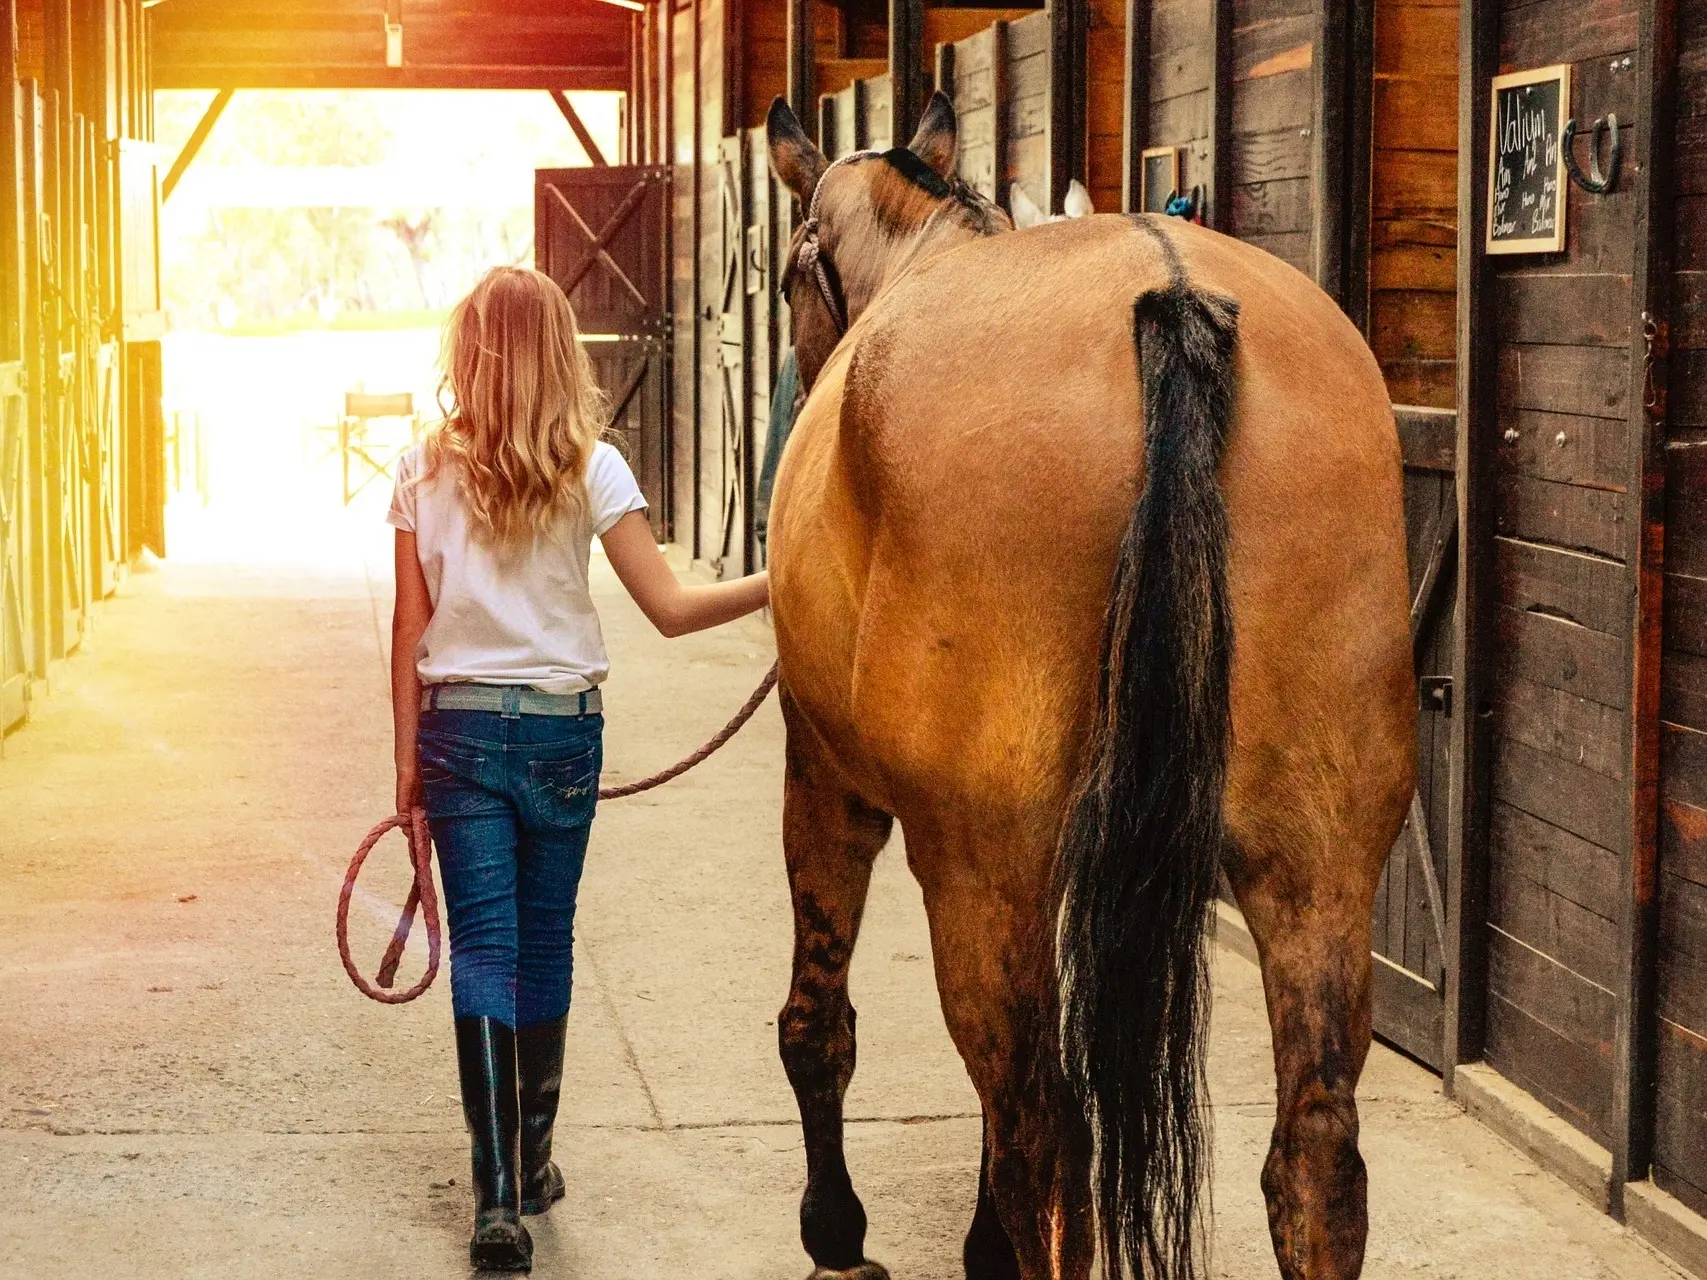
[{"x1": 908, "y1": 835, "x2": 1092, "y2": 1280}]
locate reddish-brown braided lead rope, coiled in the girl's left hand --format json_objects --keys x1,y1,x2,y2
[{"x1": 338, "y1": 662, "x2": 777, "y2": 1005}]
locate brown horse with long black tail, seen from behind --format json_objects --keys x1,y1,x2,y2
[{"x1": 768, "y1": 94, "x2": 1415, "y2": 1280}]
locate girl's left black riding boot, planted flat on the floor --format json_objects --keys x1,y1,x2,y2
[{"x1": 456, "y1": 1017, "x2": 533, "y2": 1271}]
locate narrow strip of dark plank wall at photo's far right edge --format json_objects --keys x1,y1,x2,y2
[{"x1": 1654, "y1": 5, "x2": 1707, "y2": 1213}]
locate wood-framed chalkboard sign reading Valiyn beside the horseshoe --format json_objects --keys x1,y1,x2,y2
[{"x1": 1487, "y1": 65, "x2": 1570, "y2": 253}]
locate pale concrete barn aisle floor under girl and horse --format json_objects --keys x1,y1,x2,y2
[{"x1": 0, "y1": 548, "x2": 1676, "y2": 1280}]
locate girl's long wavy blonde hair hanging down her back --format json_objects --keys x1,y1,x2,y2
[{"x1": 422, "y1": 266, "x2": 608, "y2": 550}]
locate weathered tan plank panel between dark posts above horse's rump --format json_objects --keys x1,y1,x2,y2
[{"x1": 1217, "y1": 0, "x2": 1320, "y2": 275}]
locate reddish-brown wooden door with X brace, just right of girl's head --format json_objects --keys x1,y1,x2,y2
[{"x1": 534, "y1": 166, "x2": 671, "y2": 538}]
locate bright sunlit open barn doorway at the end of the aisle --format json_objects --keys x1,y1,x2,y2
[{"x1": 155, "y1": 89, "x2": 625, "y2": 567}]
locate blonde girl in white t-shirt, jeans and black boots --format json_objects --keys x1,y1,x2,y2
[{"x1": 386, "y1": 266, "x2": 768, "y2": 1271}]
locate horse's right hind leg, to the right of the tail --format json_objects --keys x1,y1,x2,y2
[{"x1": 1234, "y1": 860, "x2": 1372, "y2": 1280}]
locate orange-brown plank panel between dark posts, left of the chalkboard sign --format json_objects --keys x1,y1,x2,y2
[{"x1": 1369, "y1": 0, "x2": 1458, "y2": 408}]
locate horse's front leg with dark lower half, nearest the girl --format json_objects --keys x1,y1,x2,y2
[{"x1": 777, "y1": 695, "x2": 893, "y2": 1280}]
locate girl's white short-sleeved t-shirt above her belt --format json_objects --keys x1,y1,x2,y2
[{"x1": 386, "y1": 442, "x2": 647, "y2": 693}]
